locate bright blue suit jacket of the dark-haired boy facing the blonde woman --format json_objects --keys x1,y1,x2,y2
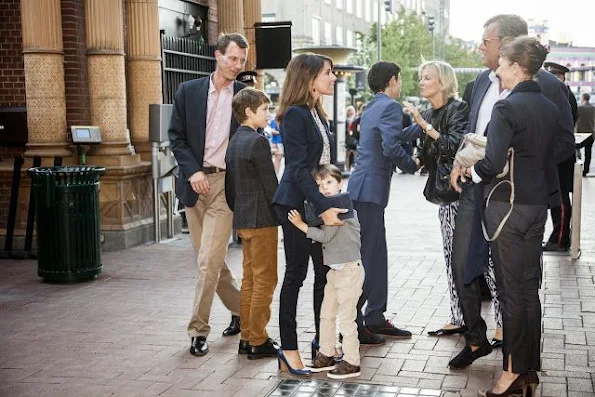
[{"x1": 348, "y1": 93, "x2": 419, "y2": 207}]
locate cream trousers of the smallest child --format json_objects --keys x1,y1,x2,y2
[{"x1": 320, "y1": 261, "x2": 365, "y2": 366}]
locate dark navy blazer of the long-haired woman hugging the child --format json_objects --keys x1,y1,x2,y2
[{"x1": 273, "y1": 105, "x2": 335, "y2": 214}]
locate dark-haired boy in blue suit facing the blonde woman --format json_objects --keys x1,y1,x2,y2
[{"x1": 348, "y1": 62, "x2": 419, "y2": 344}]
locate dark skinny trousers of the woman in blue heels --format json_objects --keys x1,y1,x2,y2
[{"x1": 275, "y1": 205, "x2": 329, "y2": 350}]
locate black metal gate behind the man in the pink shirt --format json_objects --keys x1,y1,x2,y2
[{"x1": 161, "y1": 35, "x2": 216, "y2": 103}]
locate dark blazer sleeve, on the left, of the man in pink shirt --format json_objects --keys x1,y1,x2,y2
[{"x1": 167, "y1": 84, "x2": 202, "y2": 180}]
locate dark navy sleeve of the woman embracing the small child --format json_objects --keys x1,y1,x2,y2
[{"x1": 281, "y1": 107, "x2": 331, "y2": 215}]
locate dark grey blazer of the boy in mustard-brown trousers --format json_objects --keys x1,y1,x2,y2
[{"x1": 225, "y1": 126, "x2": 279, "y2": 229}]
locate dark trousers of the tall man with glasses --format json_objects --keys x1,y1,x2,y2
[{"x1": 452, "y1": 185, "x2": 492, "y2": 346}]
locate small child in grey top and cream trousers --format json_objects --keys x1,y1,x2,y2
[{"x1": 288, "y1": 164, "x2": 364, "y2": 379}]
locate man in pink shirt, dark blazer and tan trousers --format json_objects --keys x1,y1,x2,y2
[{"x1": 168, "y1": 33, "x2": 248, "y2": 356}]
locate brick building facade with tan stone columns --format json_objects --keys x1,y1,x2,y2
[{"x1": 0, "y1": 0, "x2": 260, "y2": 249}]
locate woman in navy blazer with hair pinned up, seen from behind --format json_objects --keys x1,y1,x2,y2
[{"x1": 464, "y1": 37, "x2": 558, "y2": 397}]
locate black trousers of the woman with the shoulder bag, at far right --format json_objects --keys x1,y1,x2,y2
[{"x1": 486, "y1": 201, "x2": 547, "y2": 374}]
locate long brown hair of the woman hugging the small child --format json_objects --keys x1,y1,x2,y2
[{"x1": 277, "y1": 52, "x2": 333, "y2": 122}]
